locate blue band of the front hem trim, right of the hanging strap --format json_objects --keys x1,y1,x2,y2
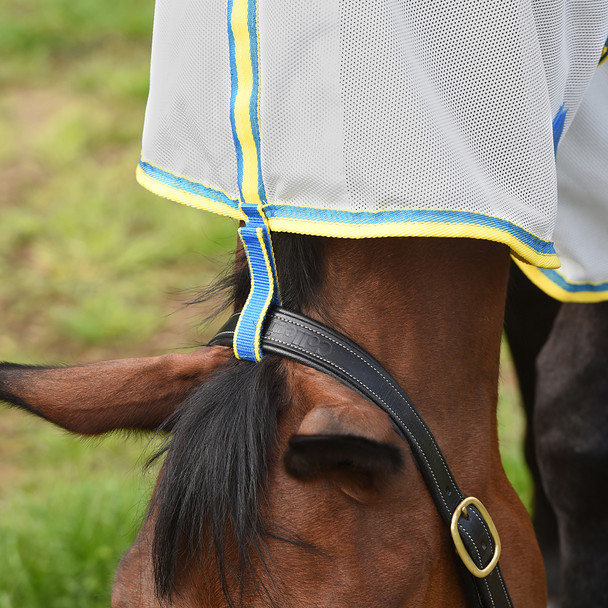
[{"x1": 264, "y1": 203, "x2": 555, "y2": 255}]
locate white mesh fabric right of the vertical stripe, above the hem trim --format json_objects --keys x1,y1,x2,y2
[{"x1": 260, "y1": 0, "x2": 606, "y2": 239}]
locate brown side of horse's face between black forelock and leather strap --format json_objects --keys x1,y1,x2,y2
[{"x1": 241, "y1": 363, "x2": 466, "y2": 608}]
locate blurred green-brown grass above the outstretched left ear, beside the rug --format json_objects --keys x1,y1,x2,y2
[{"x1": 0, "y1": 0, "x2": 235, "y2": 361}]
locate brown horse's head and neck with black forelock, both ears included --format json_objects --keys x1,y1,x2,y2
[{"x1": 0, "y1": 234, "x2": 546, "y2": 608}]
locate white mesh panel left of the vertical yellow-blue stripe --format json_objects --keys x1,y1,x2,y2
[{"x1": 142, "y1": 0, "x2": 238, "y2": 198}]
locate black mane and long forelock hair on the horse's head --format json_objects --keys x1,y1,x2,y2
[{"x1": 150, "y1": 234, "x2": 322, "y2": 606}]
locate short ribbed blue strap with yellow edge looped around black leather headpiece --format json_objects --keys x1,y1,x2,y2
[{"x1": 233, "y1": 203, "x2": 280, "y2": 361}]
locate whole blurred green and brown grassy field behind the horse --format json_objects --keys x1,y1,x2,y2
[{"x1": 0, "y1": 0, "x2": 531, "y2": 608}]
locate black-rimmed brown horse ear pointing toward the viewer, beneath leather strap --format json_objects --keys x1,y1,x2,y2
[{"x1": 284, "y1": 402, "x2": 403, "y2": 481}]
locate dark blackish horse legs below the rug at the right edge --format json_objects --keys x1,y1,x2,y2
[{"x1": 505, "y1": 265, "x2": 608, "y2": 607}]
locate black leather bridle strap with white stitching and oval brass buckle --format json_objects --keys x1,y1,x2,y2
[{"x1": 210, "y1": 307, "x2": 513, "y2": 608}]
